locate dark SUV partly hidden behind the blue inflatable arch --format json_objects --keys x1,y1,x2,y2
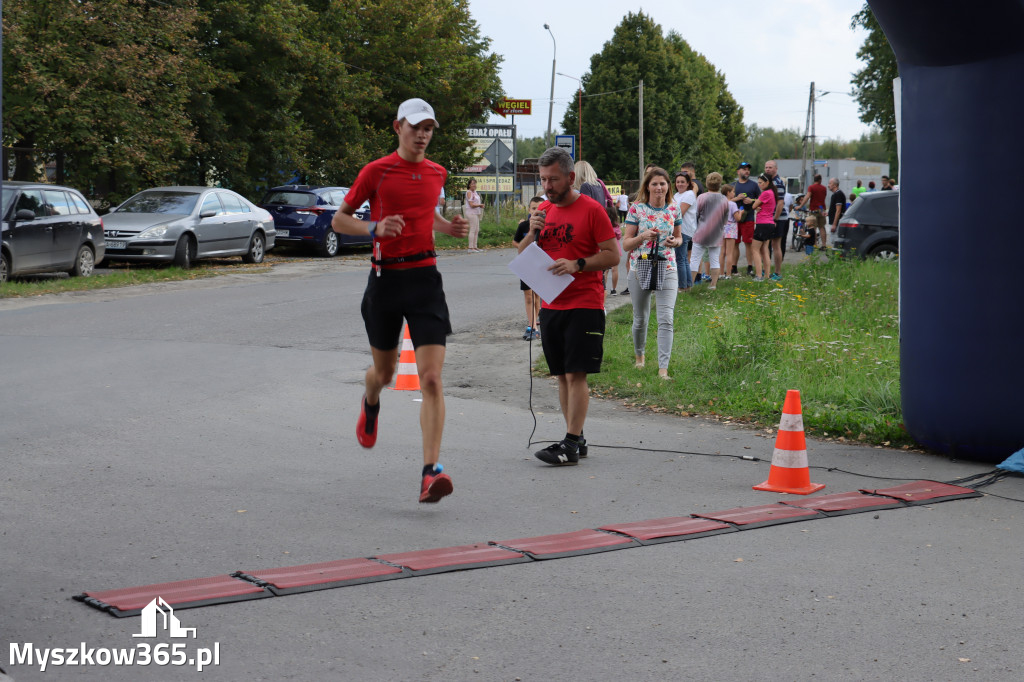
[{"x1": 833, "y1": 189, "x2": 899, "y2": 260}]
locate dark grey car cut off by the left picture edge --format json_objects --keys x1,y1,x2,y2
[{"x1": 0, "y1": 181, "x2": 106, "y2": 282}]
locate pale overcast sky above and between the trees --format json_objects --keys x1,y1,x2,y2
[{"x1": 469, "y1": 0, "x2": 868, "y2": 143}]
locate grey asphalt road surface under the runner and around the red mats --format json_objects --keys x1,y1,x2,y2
[{"x1": 0, "y1": 246, "x2": 1024, "y2": 682}]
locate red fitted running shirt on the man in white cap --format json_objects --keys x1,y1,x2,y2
[{"x1": 345, "y1": 152, "x2": 447, "y2": 269}]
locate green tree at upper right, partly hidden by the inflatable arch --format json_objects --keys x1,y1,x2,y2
[{"x1": 850, "y1": 3, "x2": 899, "y2": 177}]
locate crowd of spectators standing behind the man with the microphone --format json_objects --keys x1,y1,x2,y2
[{"x1": 514, "y1": 161, "x2": 892, "y2": 379}]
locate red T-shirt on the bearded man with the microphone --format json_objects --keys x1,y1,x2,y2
[{"x1": 537, "y1": 195, "x2": 615, "y2": 310}]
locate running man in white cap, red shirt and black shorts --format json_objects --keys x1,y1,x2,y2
[{"x1": 331, "y1": 98, "x2": 469, "y2": 502}]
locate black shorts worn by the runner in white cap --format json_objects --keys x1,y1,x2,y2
[{"x1": 361, "y1": 265, "x2": 452, "y2": 350}]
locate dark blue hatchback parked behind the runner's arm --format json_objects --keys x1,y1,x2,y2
[{"x1": 259, "y1": 184, "x2": 372, "y2": 258}]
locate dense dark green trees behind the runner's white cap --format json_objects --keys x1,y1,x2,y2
[{"x1": 185, "y1": 0, "x2": 501, "y2": 195}]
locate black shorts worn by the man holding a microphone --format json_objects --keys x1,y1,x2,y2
[{"x1": 541, "y1": 308, "x2": 604, "y2": 377}]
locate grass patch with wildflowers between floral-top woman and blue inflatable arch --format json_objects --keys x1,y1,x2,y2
[{"x1": 590, "y1": 258, "x2": 913, "y2": 445}]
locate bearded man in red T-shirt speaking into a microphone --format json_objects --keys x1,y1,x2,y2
[{"x1": 523, "y1": 147, "x2": 618, "y2": 466}]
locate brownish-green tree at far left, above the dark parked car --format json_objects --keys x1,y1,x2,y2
[{"x1": 3, "y1": 0, "x2": 209, "y2": 197}]
